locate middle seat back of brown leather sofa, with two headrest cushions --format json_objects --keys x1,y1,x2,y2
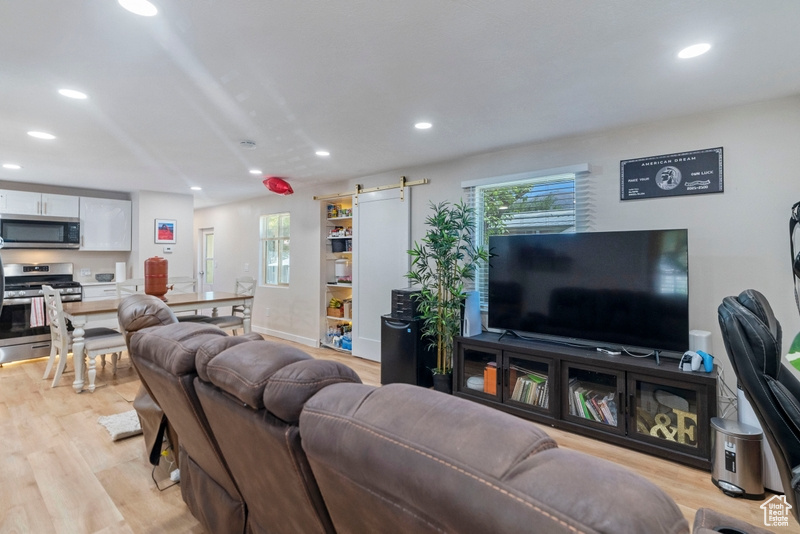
[{"x1": 195, "y1": 341, "x2": 361, "y2": 533}]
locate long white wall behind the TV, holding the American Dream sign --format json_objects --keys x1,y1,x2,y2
[{"x1": 195, "y1": 96, "x2": 800, "y2": 383}]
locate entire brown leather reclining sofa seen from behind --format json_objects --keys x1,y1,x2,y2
[{"x1": 119, "y1": 295, "x2": 764, "y2": 534}]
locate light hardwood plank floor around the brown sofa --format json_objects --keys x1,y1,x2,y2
[{"x1": 0, "y1": 340, "x2": 800, "y2": 534}]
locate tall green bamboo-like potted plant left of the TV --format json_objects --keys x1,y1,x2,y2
[{"x1": 406, "y1": 200, "x2": 489, "y2": 390}]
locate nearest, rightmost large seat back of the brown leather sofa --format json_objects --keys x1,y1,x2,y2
[{"x1": 300, "y1": 384, "x2": 689, "y2": 534}]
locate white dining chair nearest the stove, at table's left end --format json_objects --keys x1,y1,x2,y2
[{"x1": 42, "y1": 285, "x2": 128, "y2": 387}]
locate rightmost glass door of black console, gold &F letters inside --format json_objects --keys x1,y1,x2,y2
[{"x1": 628, "y1": 373, "x2": 710, "y2": 455}]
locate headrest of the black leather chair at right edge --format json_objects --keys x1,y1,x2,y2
[{"x1": 718, "y1": 289, "x2": 782, "y2": 378}]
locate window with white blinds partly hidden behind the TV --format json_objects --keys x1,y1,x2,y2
[{"x1": 462, "y1": 166, "x2": 588, "y2": 311}]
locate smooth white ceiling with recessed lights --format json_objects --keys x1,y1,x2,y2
[{"x1": 0, "y1": 0, "x2": 800, "y2": 207}]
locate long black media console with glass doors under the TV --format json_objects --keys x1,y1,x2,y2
[{"x1": 453, "y1": 333, "x2": 717, "y2": 471}]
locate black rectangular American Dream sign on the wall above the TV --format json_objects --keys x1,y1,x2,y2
[{"x1": 619, "y1": 147, "x2": 723, "y2": 200}]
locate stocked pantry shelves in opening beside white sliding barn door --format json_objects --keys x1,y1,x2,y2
[{"x1": 320, "y1": 196, "x2": 353, "y2": 353}]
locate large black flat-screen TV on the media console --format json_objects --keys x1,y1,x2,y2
[{"x1": 488, "y1": 230, "x2": 689, "y2": 352}]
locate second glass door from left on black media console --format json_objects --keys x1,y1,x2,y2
[{"x1": 503, "y1": 352, "x2": 554, "y2": 413}]
